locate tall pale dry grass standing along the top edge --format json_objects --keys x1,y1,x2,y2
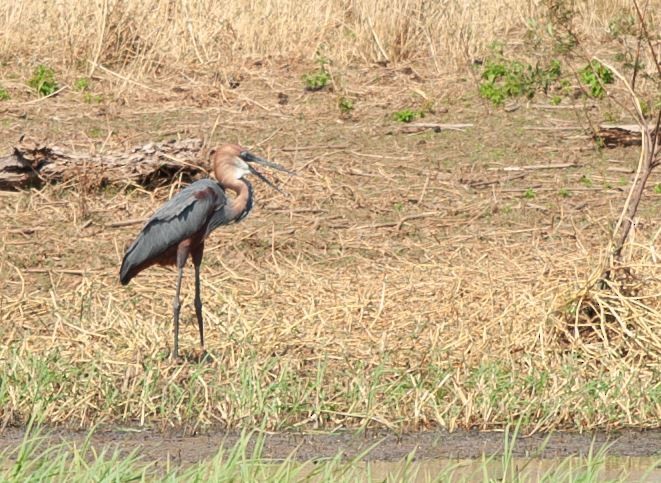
[{"x1": 0, "y1": 0, "x2": 648, "y2": 77}]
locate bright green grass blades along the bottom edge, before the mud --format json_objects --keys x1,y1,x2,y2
[{"x1": 0, "y1": 429, "x2": 661, "y2": 483}]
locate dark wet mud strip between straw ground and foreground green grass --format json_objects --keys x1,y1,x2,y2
[{"x1": 0, "y1": 428, "x2": 661, "y2": 465}]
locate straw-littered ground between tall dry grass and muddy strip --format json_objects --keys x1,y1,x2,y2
[{"x1": 0, "y1": 2, "x2": 661, "y2": 440}]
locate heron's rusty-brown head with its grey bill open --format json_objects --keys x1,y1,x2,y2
[{"x1": 211, "y1": 144, "x2": 294, "y2": 193}]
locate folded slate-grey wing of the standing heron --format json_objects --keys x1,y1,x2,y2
[{"x1": 120, "y1": 180, "x2": 226, "y2": 286}]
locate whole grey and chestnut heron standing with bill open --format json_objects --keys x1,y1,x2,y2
[{"x1": 119, "y1": 145, "x2": 287, "y2": 357}]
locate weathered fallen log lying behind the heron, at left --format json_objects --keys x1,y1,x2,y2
[{"x1": 0, "y1": 139, "x2": 204, "y2": 189}]
